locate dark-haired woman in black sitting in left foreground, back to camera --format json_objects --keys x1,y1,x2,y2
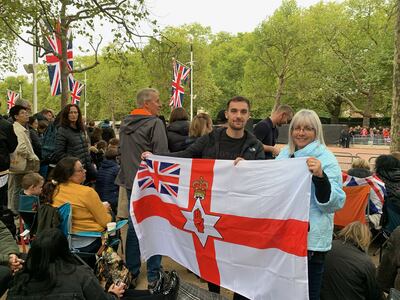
[{"x1": 7, "y1": 228, "x2": 169, "y2": 300}]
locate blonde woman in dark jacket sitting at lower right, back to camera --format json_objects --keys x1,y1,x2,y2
[{"x1": 321, "y1": 221, "x2": 382, "y2": 300}]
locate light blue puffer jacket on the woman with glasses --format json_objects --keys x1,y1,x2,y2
[{"x1": 276, "y1": 141, "x2": 346, "y2": 252}]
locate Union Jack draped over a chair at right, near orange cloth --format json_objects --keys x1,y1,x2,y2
[{"x1": 342, "y1": 173, "x2": 386, "y2": 213}]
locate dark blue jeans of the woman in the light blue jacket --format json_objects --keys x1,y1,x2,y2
[{"x1": 308, "y1": 251, "x2": 326, "y2": 300}]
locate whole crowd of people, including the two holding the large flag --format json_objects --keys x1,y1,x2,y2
[{"x1": 0, "y1": 88, "x2": 400, "y2": 300}]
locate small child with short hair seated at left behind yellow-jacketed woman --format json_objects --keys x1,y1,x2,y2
[{"x1": 18, "y1": 173, "x2": 44, "y2": 232}]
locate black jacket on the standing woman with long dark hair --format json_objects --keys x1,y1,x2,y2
[{"x1": 54, "y1": 126, "x2": 91, "y2": 168}]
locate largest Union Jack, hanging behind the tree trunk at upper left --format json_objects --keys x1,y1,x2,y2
[{"x1": 46, "y1": 22, "x2": 74, "y2": 96}]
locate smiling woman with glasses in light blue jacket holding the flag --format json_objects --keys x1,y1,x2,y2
[{"x1": 276, "y1": 109, "x2": 346, "y2": 300}]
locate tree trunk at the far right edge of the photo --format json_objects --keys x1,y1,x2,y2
[{"x1": 390, "y1": 0, "x2": 400, "y2": 152}]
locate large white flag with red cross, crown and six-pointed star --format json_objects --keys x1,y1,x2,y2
[{"x1": 130, "y1": 156, "x2": 311, "y2": 300}]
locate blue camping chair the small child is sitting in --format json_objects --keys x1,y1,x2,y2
[{"x1": 18, "y1": 194, "x2": 40, "y2": 253}]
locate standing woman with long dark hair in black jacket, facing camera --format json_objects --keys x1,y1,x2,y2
[{"x1": 54, "y1": 104, "x2": 96, "y2": 181}]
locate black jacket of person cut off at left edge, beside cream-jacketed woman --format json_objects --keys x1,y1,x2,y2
[{"x1": 0, "y1": 116, "x2": 18, "y2": 172}]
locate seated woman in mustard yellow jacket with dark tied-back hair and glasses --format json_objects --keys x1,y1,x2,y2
[{"x1": 41, "y1": 157, "x2": 112, "y2": 265}]
